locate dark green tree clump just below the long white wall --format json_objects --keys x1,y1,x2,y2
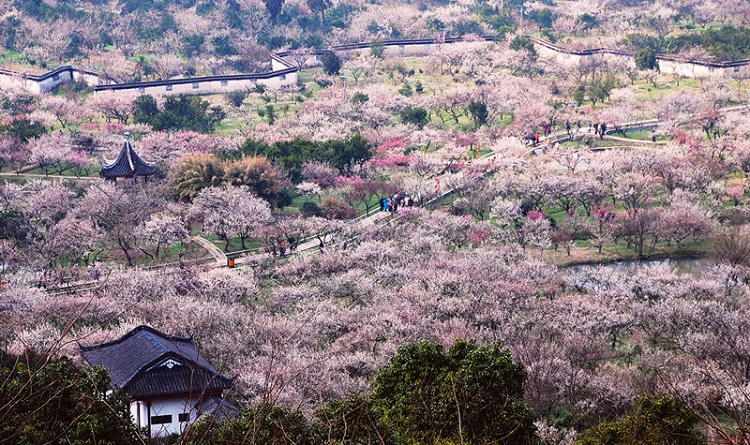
[{"x1": 133, "y1": 94, "x2": 226, "y2": 133}]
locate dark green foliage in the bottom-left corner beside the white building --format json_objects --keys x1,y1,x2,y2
[{"x1": 0, "y1": 356, "x2": 138, "y2": 445}]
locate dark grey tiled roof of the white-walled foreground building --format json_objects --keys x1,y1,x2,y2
[{"x1": 79, "y1": 326, "x2": 234, "y2": 398}]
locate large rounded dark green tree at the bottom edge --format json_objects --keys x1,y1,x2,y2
[{"x1": 373, "y1": 340, "x2": 534, "y2": 445}]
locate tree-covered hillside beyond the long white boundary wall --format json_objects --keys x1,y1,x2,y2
[{"x1": 0, "y1": 0, "x2": 750, "y2": 81}]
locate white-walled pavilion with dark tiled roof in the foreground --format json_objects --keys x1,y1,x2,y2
[{"x1": 78, "y1": 326, "x2": 238, "y2": 437}]
